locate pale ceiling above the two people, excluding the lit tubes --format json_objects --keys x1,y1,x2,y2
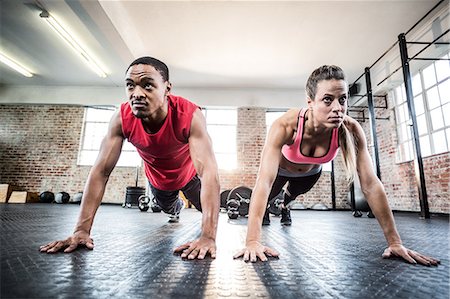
[{"x1": 0, "y1": 0, "x2": 439, "y2": 106}]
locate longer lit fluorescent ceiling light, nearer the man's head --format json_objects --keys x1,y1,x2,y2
[{"x1": 39, "y1": 10, "x2": 106, "y2": 78}]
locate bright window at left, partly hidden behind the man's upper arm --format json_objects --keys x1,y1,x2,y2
[{"x1": 78, "y1": 107, "x2": 142, "y2": 167}]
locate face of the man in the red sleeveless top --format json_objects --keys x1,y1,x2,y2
[{"x1": 125, "y1": 64, "x2": 170, "y2": 118}]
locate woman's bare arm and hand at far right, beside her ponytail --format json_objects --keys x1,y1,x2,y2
[{"x1": 349, "y1": 119, "x2": 439, "y2": 265}]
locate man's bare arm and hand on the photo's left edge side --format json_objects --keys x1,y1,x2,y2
[{"x1": 40, "y1": 111, "x2": 124, "y2": 253}]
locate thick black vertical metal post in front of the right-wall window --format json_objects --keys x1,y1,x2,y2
[{"x1": 398, "y1": 33, "x2": 430, "y2": 219}]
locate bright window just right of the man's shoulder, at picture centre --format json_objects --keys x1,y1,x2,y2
[{"x1": 202, "y1": 108, "x2": 237, "y2": 170}]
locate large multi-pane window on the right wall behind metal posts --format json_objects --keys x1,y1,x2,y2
[{"x1": 393, "y1": 54, "x2": 450, "y2": 162}]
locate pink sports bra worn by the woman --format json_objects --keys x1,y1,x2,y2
[{"x1": 281, "y1": 108, "x2": 339, "y2": 164}]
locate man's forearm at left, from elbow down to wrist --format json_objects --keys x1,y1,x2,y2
[{"x1": 75, "y1": 172, "x2": 108, "y2": 233}]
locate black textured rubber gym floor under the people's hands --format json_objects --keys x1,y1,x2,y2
[{"x1": 0, "y1": 204, "x2": 450, "y2": 299}]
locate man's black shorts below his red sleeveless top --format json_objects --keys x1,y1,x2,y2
[{"x1": 149, "y1": 175, "x2": 202, "y2": 214}]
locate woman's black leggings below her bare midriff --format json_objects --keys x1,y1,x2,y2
[{"x1": 269, "y1": 170, "x2": 322, "y2": 206}]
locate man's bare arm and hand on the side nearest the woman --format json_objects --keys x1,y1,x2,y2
[{"x1": 175, "y1": 109, "x2": 220, "y2": 259}]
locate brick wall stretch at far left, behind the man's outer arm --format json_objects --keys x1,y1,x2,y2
[{"x1": 0, "y1": 105, "x2": 145, "y2": 203}]
